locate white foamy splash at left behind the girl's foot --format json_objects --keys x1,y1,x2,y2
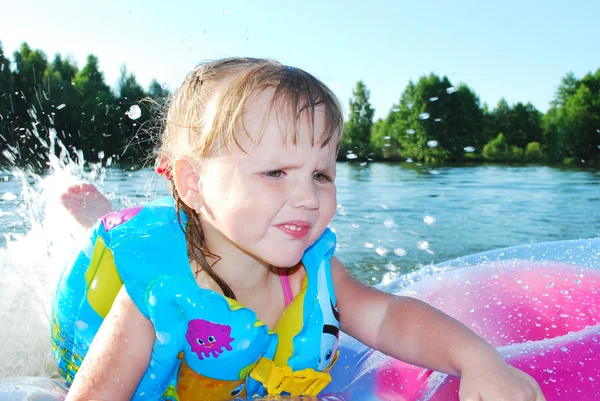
[{"x1": 0, "y1": 126, "x2": 111, "y2": 377}]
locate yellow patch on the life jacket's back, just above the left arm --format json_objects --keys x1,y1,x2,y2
[{"x1": 85, "y1": 237, "x2": 123, "y2": 318}]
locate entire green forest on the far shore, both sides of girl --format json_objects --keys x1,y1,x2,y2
[{"x1": 0, "y1": 42, "x2": 600, "y2": 168}]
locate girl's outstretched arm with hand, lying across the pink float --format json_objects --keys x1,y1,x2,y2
[{"x1": 331, "y1": 257, "x2": 545, "y2": 401}]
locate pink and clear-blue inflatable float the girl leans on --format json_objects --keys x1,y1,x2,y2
[{"x1": 0, "y1": 238, "x2": 600, "y2": 401}]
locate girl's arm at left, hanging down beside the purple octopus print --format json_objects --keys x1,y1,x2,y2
[{"x1": 65, "y1": 286, "x2": 155, "y2": 401}]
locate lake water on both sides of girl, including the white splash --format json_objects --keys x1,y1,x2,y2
[{"x1": 0, "y1": 160, "x2": 600, "y2": 377}]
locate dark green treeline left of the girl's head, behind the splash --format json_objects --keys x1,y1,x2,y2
[{"x1": 0, "y1": 42, "x2": 169, "y2": 168}]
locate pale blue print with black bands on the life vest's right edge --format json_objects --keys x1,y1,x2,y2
[{"x1": 318, "y1": 262, "x2": 340, "y2": 371}]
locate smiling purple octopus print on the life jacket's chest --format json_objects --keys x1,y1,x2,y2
[{"x1": 185, "y1": 319, "x2": 234, "y2": 360}]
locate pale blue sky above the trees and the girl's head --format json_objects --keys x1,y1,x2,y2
[{"x1": 0, "y1": 0, "x2": 600, "y2": 117}]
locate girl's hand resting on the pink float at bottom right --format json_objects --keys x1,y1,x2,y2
[{"x1": 458, "y1": 360, "x2": 546, "y2": 401}]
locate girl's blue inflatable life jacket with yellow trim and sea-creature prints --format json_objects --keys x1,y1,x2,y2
[{"x1": 51, "y1": 199, "x2": 339, "y2": 401}]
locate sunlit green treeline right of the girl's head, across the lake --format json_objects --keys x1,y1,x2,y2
[{"x1": 340, "y1": 69, "x2": 600, "y2": 165}]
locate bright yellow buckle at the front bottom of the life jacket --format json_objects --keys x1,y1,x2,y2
[{"x1": 250, "y1": 358, "x2": 331, "y2": 397}]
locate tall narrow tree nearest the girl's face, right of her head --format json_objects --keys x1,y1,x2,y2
[{"x1": 340, "y1": 81, "x2": 375, "y2": 159}]
